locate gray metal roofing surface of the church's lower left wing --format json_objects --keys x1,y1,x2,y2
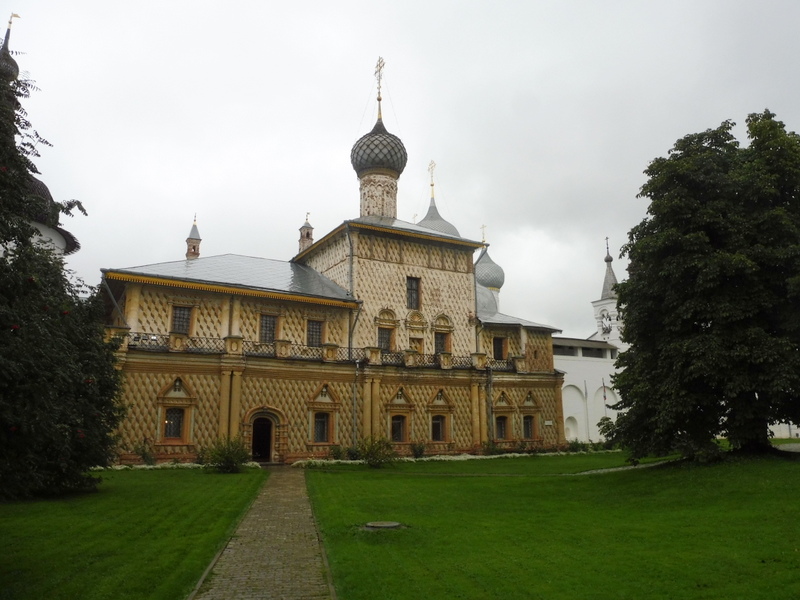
[{"x1": 102, "y1": 254, "x2": 353, "y2": 302}]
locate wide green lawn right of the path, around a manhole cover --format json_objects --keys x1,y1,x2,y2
[{"x1": 308, "y1": 454, "x2": 800, "y2": 600}]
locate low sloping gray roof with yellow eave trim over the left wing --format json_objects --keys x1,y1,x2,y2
[{"x1": 101, "y1": 254, "x2": 357, "y2": 308}]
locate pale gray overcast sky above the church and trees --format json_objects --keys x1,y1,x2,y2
[{"x1": 6, "y1": 0, "x2": 800, "y2": 337}]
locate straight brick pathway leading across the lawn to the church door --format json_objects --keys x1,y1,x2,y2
[{"x1": 189, "y1": 466, "x2": 336, "y2": 600}]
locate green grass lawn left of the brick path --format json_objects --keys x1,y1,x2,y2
[{"x1": 0, "y1": 469, "x2": 267, "y2": 600}]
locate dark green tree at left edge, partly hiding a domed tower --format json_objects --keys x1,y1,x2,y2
[{"x1": 0, "y1": 34, "x2": 121, "y2": 498}]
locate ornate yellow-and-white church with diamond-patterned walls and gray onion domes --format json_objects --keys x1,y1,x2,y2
[{"x1": 102, "y1": 65, "x2": 565, "y2": 462}]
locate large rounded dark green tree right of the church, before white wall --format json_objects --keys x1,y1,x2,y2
[{"x1": 614, "y1": 111, "x2": 800, "y2": 458}]
